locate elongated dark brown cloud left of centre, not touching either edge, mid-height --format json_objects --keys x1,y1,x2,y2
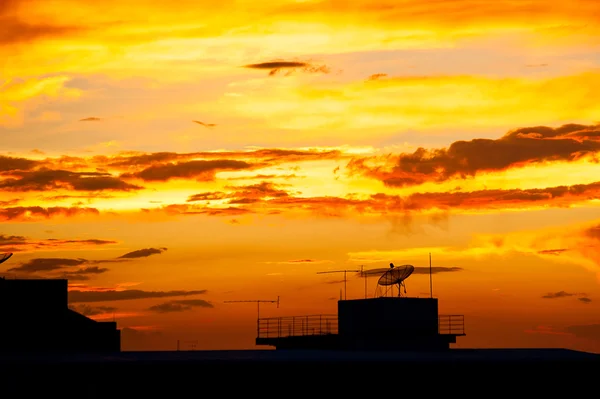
[{"x1": 122, "y1": 159, "x2": 257, "y2": 181}]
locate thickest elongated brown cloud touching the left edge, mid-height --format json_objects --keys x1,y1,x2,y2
[{"x1": 0, "y1": 169, "x2": 143, "y2": 191}]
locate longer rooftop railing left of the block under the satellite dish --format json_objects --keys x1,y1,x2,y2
[{"x1": 257, "y1": 314, "x2": 338, "y2": 338}]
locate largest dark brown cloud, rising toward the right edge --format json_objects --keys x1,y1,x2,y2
[{"x1": 347, "y1": 124, "x2": 600, "y2": 187}]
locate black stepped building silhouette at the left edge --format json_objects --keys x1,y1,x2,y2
[{"x1": 0, "y1": 278, "x2": 121, "y2": 353}]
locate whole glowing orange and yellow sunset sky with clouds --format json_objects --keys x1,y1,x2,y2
[{"x1": 0, "y1": 0, "x2": 600, "y2": 352}]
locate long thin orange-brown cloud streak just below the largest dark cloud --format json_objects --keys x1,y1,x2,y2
[{"x1": 157, "y1": 178, "x2": 600, "y2": 222}]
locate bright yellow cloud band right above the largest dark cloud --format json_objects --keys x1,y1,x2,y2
[{"x1": 229, "y1": 72, "x2": 600, "y2": 139}]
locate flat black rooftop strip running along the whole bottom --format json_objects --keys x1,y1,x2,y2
[{"x1": 0, "y1": 349, "x2": 600, "y2": 398}]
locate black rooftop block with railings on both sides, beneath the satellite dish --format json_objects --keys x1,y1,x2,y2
[{"x1": 256, "y1": 297, "x2": 465, "y2": 351}]
